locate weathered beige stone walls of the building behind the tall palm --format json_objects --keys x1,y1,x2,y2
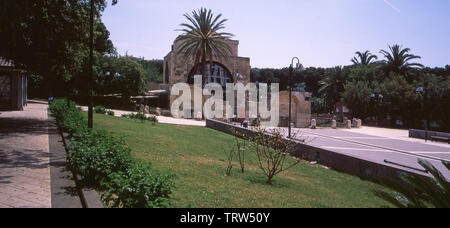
[{"x1": 160, "y1": 37, "x2": 311, "y2": 127}]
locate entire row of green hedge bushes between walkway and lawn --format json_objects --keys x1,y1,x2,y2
[{"x1": 50, "y1": 99, "x2": 174, "y2": 208}]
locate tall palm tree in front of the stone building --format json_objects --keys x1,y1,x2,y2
[{"x1": 176, "y1": 8, "x2": 234, "y2": 83}]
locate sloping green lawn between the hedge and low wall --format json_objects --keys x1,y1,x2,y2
[{"x1": 90, "y1": 114, "x2": 388, "y2": 208}]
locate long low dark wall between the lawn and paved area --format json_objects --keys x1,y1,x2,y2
[{"x1": 206, "y1": 119, "x2": 423, "y2": 183}]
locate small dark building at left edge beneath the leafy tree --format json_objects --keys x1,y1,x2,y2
[{"x1": 0, "y1": 57, "x2": 27, "y2": 111}]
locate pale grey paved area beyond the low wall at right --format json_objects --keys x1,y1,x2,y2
[{"x1": 283, "y1": 129, "x2": 450, "y2": 180}]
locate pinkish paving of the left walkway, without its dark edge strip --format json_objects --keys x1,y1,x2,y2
[{"x1": 0, "y1": 103, "x2": 51, "y2": 208}]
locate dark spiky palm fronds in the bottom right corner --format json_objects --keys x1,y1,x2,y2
[{"x1": 375, "y1": 160, "x2": 450, "y2": 208}]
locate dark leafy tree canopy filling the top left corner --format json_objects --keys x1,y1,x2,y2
[{"x1": 0, "y1": 0, "x2": 116, "y2": 87}]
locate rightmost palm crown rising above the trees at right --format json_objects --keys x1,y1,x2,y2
[{"x1": 380, "y1": 44, "x2": 423, "y2": 75}]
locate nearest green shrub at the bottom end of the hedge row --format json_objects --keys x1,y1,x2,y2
[{"x1": 102, "y1": 163, "x2": 174, "y2": 208}]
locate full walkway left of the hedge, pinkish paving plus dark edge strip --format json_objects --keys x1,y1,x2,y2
[{"x1": 0, "y1": 101, "x2": 82, "y2": 208}]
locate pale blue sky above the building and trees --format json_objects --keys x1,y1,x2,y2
[{"x1": 103, "y1": 0, "x2": 450, "y2": 68}]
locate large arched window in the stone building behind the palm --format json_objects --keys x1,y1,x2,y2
[{"x1": 188, "y1": 62, "x2": 233, "y2": 87}]
